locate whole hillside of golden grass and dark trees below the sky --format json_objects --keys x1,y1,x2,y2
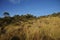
[{"x1": 0, "y1": 13, "x2": 60, "y2": 40}]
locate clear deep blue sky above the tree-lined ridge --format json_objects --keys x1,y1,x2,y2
[{"x1": 0, "y1": 0, "x2": 60, "y2": 16}]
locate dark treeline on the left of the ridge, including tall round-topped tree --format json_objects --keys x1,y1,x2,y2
[{"x1": 0, "y1": 12, "x2": 37, "y2": 27}]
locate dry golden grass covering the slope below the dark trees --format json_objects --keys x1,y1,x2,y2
[{"x1": 0, "y1": 17, "x2": 60, "y2": 40}]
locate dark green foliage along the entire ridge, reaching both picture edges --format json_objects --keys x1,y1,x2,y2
[{"x1": 0, "y1": 12, "x2": 60, "y2": 27}]
